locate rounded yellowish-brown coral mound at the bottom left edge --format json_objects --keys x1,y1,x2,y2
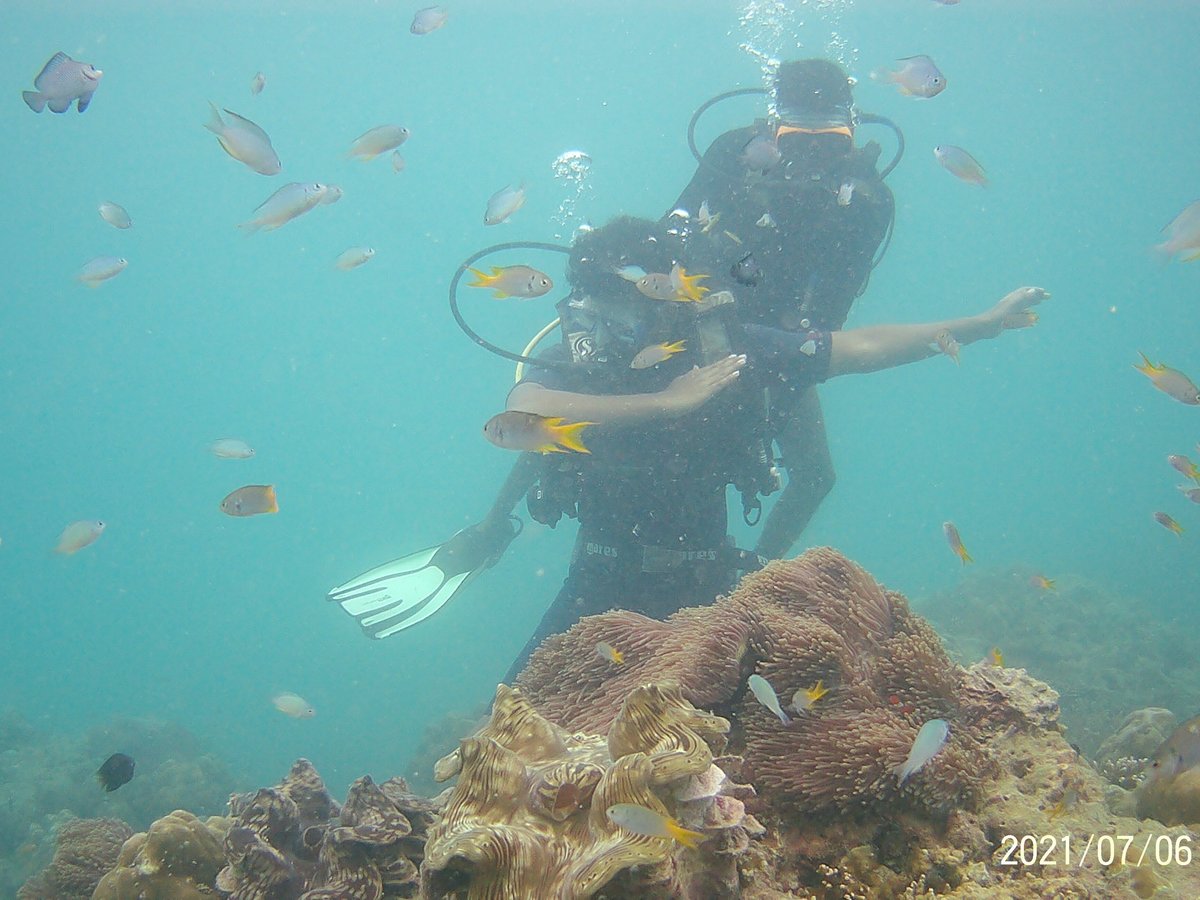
[{"x1": 92, "y1": 810, "x2": 229, "y2": 900}]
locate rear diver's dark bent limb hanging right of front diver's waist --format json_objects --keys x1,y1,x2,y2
[{"x1": 755, "y1": 388, "x2": 835, "y2": 559}]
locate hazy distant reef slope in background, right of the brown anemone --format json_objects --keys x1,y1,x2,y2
[{"x1": 913, "y1": 566, "x2": 1200, "y2": 755}]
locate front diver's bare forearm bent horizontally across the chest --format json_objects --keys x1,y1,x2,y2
[{"x1": 508, "y1": 356, "x2": 746, "y2": 425}]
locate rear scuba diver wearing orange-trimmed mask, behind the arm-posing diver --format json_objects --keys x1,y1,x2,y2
[{"x1": 664, "y1": 59, "x2": 902, "y2": 558}]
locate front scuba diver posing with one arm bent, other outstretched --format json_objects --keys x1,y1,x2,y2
[{"x1": 489, "y1": 218, "x2": 1046, "y2": 683}]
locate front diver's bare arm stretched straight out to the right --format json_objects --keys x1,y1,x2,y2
[{"x1": 829, "y1": 288, "x2": 1050, "y2": 378}]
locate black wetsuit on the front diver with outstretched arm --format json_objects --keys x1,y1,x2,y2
[{"x1": 505, "y1": 326, "x2": 829, "y2": 684}]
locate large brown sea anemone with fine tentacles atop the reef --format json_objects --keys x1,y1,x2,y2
[{"x1": 517, "y1": 548, "x2": 998, "y2": 814}]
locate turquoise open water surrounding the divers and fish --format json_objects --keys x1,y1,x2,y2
[{"x1": 0, "y1": 0, "x2": 1200, "y2": 811}]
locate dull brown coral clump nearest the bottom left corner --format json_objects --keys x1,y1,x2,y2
[{"x1": 17, "y1": 818, "x2": 133, "y2": 900}]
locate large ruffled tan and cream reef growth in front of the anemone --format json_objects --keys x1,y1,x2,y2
[{"x1": 421, "y1": 684, "x2": 761, "y2": 900}]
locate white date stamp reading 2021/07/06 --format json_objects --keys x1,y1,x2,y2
[{"x1": 992, "y1": 833, "x2": 1195, "y2": 868}]
